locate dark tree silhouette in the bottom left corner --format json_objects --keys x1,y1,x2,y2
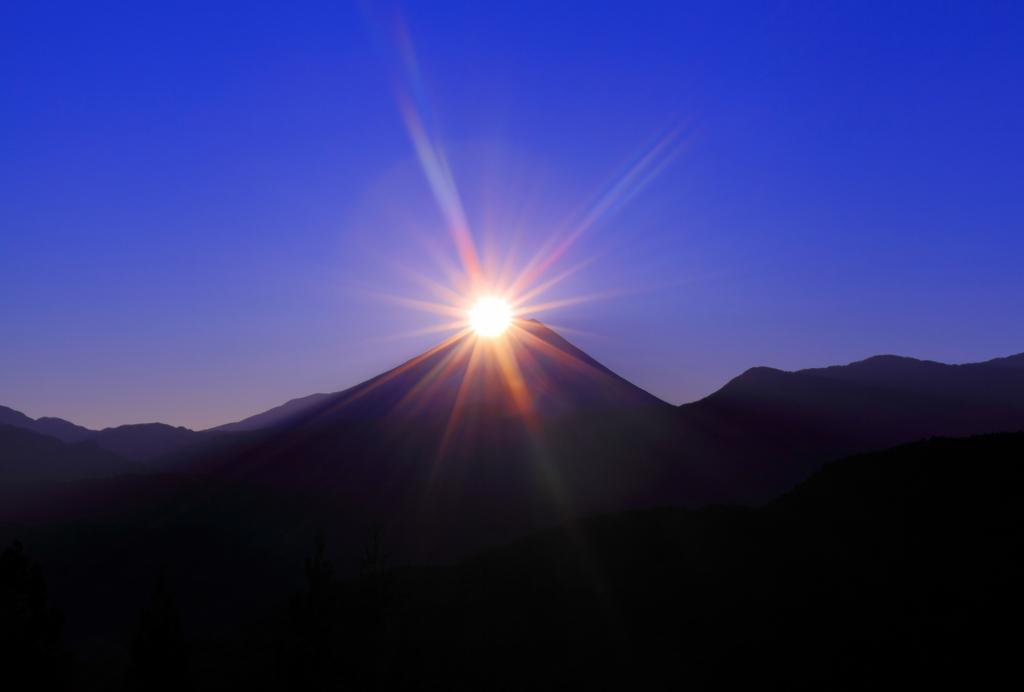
[{"x1": 0, "y1": 542, "x2": 71, "y2": 689}]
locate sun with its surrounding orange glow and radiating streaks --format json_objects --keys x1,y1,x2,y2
[{"x1": 348, "y1": 17, "x2": 687, "y2": 462}]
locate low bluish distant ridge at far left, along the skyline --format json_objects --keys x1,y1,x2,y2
[{"x1": 0, "y1": 406, "x2": 216, "y2": 470}]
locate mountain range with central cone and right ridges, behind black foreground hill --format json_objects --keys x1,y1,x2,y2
[{"x1": 0, "y1": 320, "x2": 1024, "y2": 559}]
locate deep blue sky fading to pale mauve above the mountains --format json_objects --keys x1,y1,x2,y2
[{"x1": 0, "y1": 0, "x2": 1024, "y2": 427}]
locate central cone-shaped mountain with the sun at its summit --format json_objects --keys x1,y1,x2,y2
[{"x1": 182, "y1": 320, "x2": 688, "y2": 559}]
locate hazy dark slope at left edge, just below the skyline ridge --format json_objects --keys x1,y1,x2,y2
[{"x1": 0, "y1": 424, "x2": 138, "y2": 483}]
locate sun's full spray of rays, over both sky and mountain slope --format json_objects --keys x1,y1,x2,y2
[{"x1": 352, "y1": 17, "x2": 688, "y2": 491}]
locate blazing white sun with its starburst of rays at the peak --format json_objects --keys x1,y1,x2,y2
[{"x1": 352, "y1": 18, "x2": 685, "y2": 449}]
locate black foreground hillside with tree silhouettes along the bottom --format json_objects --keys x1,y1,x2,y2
[{"x1": 0, "y1": 433, "x2": 1024, "y2": 690}]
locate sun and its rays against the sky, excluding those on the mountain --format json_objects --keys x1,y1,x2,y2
[{"x1": 380, "y1": 21, "x2": 687, "y2": 350}]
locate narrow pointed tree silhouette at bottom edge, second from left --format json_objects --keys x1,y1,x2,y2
[{"x1": 127, "y1": 573, "x2": 189, "y2": 692}]
